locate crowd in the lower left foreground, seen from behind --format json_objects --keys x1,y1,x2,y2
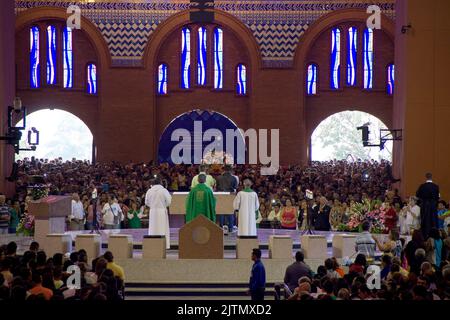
[{"x1": 0, "y1": 242, "x2": 125, "y2": 301}]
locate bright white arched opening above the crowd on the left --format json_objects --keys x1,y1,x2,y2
[{"x1": 16, "y1": 109, "x2": 94, "y2": 161}]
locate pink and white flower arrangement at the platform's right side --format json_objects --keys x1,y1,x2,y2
[{"x1": 338, "y1": 199, "x2": 386, "y2": 234}]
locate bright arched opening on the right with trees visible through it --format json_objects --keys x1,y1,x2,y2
[{"x1": 311, "y1": 111, "x2": 393, "y2": 161}]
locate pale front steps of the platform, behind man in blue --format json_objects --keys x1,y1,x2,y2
[{"x1": 116, "y1": 258, "x2": 316, "y2": 300}]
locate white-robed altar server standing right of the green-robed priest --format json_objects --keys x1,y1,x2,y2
[{"x1": 233, "y1": 179, "x2": 259, "y2": 236}]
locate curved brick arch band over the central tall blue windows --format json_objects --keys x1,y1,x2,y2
[{"x1": 143, "y1": 9, "x2": 262, "y2": 73}]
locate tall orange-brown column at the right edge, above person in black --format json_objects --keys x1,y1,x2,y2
[{"x1": 393, "y1": 0, "x2": 450, "y2": 200}]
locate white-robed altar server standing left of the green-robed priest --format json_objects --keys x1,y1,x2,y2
[{"x1": 145, "y1": 177, "x2": 172, "y2": 249}]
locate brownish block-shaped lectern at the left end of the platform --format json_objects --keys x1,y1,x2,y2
[{"x1": 29, "y1": 196, "x2": 72, "y2": 248}]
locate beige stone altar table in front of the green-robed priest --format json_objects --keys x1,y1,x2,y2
[{"x1": 169, "y1": 192, "x2": 236, "y2": 215}]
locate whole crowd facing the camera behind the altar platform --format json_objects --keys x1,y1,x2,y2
[{"x1": 1, "y1": 158, "x2": 398, "y2": 232}]
